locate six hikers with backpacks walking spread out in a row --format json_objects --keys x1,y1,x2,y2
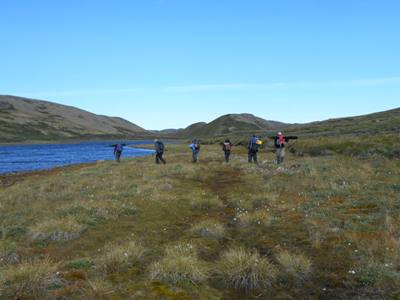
[{"x1": 113, "y1": 132, "x2": 297, "y2": 164}]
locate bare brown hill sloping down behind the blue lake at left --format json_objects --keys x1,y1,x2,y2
[{"x1": 0, "y1": 95, "x2": 152, "y2": 142}]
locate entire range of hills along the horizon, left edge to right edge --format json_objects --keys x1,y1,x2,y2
[{"x1": 0, "y1": 95, "x2": 400, "y2": 143}]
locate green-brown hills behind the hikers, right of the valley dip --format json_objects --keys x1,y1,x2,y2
[{"x1": 161, "y1": 108, "x2": 400, "y2": 142}]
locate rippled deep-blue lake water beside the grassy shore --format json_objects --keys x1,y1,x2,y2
[{"x1": 0, "y1": 141, "x2": 154, "y2": 174}]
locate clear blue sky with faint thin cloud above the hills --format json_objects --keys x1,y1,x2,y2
[{"x1": 0, "y1": 0, "x2": 400, "y2": 129}]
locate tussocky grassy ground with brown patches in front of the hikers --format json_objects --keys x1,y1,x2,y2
[{"x1": 0, "y1": 145, "x2": 400, "y2": 299}]
